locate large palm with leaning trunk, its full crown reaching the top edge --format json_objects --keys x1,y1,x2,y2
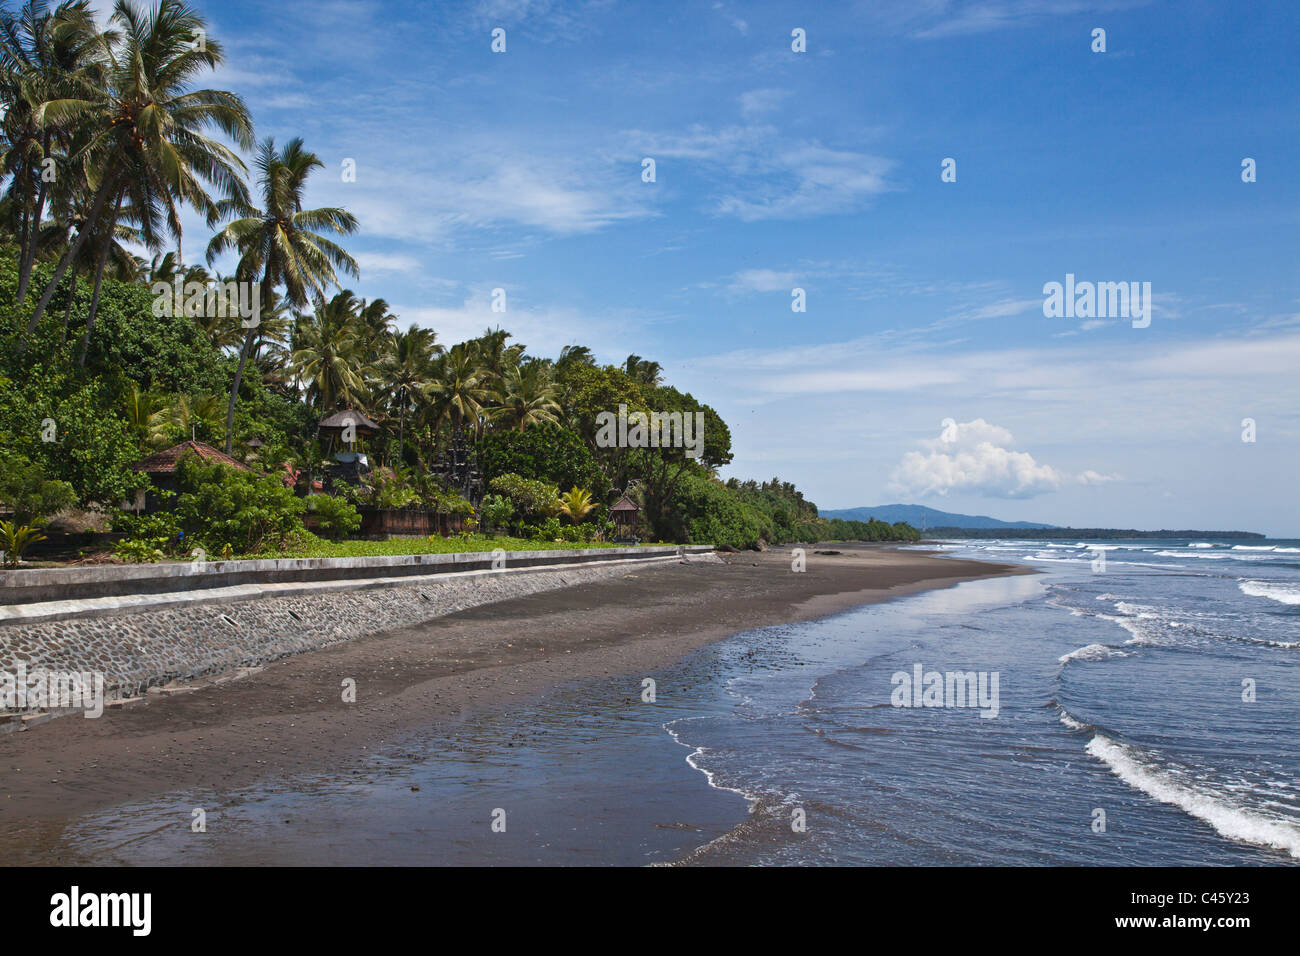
[{"x1": 20, "y1": 0, "x2": 254, "y2": 351}]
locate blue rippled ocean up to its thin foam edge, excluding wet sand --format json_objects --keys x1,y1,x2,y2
[{"x1": 670, "y1": 540, "x2": 1300, "y2": 866}]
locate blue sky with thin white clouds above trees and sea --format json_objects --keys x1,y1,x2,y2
[{"x1": 124, "y1": 0, "x2": 1300, "y2": 536}]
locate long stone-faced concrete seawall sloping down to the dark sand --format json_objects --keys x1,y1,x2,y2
[{"x1": 0, "y1": 546, "x2": 716, "y2": 732}]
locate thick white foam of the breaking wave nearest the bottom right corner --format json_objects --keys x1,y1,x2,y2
[{"x1": 1067, "y1": 724, "x2": 1300, "y2": 858}]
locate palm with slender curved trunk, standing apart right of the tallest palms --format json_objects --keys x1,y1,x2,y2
[{"x1": 208, "y1": 138, "x2": 360, "y2": 454}]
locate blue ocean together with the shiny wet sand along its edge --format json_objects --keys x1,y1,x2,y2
[{"x1": 43, "y1": 538, "x2": 1300, "y2": 866}]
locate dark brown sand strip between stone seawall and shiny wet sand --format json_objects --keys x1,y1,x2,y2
[{"x1": 0, "y1": 544, "x2": 1034, "y2": 864}]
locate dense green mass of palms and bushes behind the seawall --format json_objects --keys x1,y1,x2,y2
[{"x1": 0, "y1": 0, "x2": 917, "y2": 561}]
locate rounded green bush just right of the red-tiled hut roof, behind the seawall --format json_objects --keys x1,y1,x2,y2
[{"x1": 176, "y1": 455, "x2": 306, "y2": 554}]
